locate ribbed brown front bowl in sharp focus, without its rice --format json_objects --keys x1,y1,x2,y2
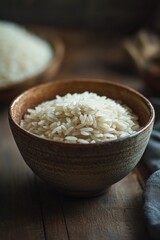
[{"x1": 9, "y1": 80, "x2": 154, "y2": 197}]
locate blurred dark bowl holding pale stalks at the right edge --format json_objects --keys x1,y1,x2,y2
[{"x1": 123, "y1": 30, "x2": 160, "y2": 95}]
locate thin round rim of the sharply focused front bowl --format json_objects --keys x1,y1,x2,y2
[{"x1": 8, "y1": 78, "x2": 155, "y2": 148}]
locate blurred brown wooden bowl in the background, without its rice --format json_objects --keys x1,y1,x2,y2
[{"x1": 0, "y1": 30, "x2": 65, "y2": 103}]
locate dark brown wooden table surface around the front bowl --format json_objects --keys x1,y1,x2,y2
[{"x1": 0, "y1": 27, "x2": 150, "y2": 240}]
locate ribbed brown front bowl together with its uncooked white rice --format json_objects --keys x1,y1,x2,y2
[{"x1": 9, "y1": 79, "x2": 154, "y2": 197}]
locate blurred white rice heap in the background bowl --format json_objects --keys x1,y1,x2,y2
[{"x1": 0, "y1": 21, "x2": 53, "y2": 86}]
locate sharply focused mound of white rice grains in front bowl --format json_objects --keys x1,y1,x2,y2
[{"x1": 20, "y1": 92, "x2": 140, "y2": 143}]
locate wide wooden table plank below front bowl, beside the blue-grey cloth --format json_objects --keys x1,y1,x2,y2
[{"x1": 59, "y1": 173, "x2": 149, "y2": 240}]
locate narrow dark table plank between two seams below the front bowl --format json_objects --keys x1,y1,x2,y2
[{"x1": 36, "y1": 178, "x2": 70, "y2": 240}]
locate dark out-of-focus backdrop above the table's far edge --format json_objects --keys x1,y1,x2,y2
[{"x1": 0, "y1": 0, "x2": 160, "y2": 32}]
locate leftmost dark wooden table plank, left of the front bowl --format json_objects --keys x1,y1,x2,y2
[{"x1": 0, "y1": 109, "x2": 45, "y2": 240}]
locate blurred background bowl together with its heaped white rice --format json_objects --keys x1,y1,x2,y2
[{"x1": 0, "y1": 20, "x2": 64, "y2": 102}]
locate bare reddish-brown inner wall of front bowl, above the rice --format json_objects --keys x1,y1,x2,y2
[{"x1": 11, "y1": 80, "x2": 154, "y2": 127}]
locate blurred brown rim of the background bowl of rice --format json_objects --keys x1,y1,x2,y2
[{"x1": 0, "y1": 27, "x2": 65, "y2": 92}]
